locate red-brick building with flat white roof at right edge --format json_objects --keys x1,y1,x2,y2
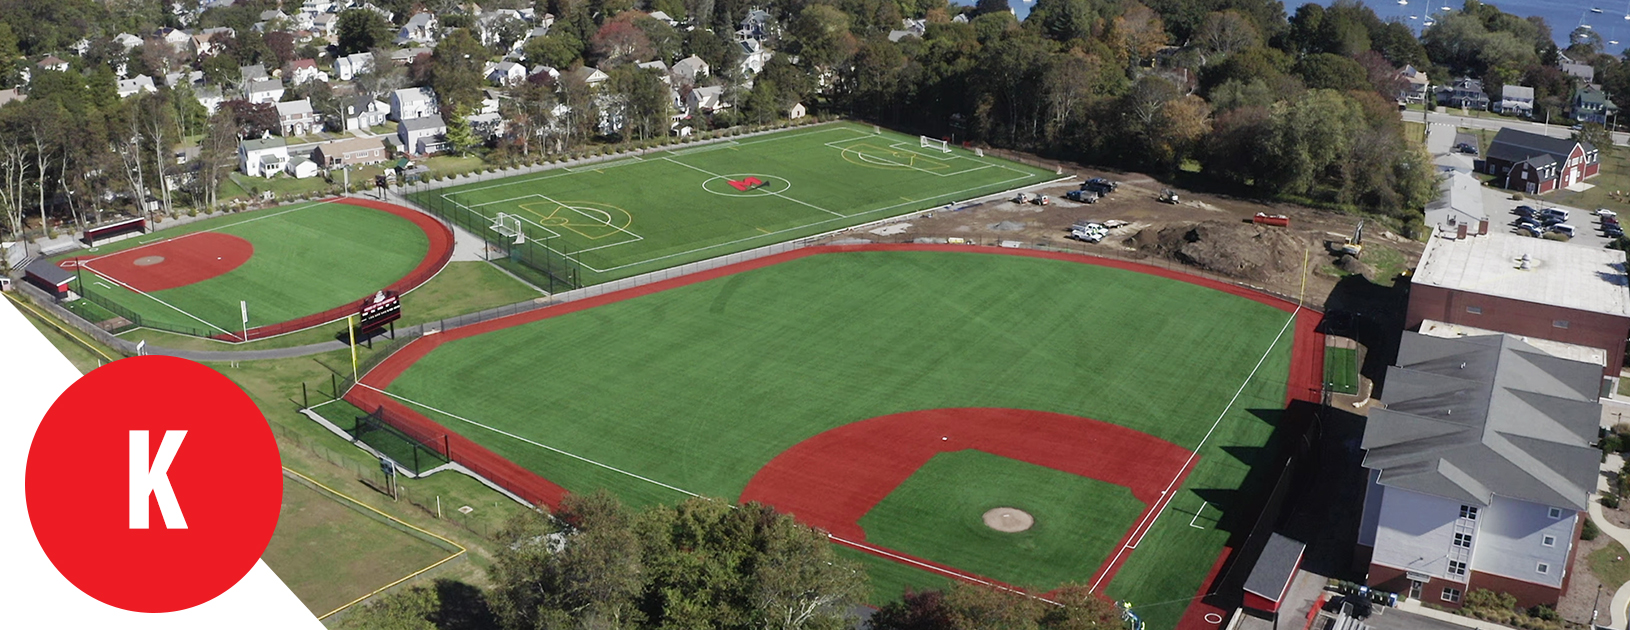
[{"x1": 1405, "y1": 230, "x2": 1630, "y2": 378}]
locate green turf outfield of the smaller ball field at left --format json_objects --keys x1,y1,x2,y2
[{"x1": 75, "y1": 202, "x2": 430, "y2": 335}]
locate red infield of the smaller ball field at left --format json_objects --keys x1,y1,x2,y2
[{"x1": 57, "y1": 231, "x2": 254, "y2": 293}]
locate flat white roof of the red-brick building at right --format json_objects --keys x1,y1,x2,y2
[{"x1": 1413, "y1": 231, "x2": 1630, "y2": 317}]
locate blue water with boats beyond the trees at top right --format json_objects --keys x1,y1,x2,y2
[{"x1": 952, "y1": 0, "x2": 1630, "y2": 54}]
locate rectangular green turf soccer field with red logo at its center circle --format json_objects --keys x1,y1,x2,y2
[{"x1": 412, "y1": 124, "x2": 1056, "y2": 285}]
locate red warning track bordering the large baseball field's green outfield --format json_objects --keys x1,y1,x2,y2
[{"x1": 344, "y1": 244, "x2": 1324, "y2": 630}]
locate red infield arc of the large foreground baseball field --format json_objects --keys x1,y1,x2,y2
[{"x1": 742, "y1": 409, "x2": 1193, "y2": 592}]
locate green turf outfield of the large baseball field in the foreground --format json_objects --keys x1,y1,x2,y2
[{"x1": 390, "y1": 252, "x2": 1293, "y2": 627}]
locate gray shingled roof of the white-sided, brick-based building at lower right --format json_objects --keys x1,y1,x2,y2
[{"x1": 1363, "y1": 332, "x2": 1602, "y2": 511}]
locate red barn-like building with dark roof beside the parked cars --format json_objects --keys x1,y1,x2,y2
[{"x1": 1477, "y1": 129, "x2": 1601, "y2": 194}]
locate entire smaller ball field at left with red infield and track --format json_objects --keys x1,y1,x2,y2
[{"x1": 57, "y1": 199, "x2": 452, "y2": 340}]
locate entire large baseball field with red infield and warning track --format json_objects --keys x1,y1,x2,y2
[{"x1": 347, "y1": 246, "x2": 1322, "y2": 627}]
